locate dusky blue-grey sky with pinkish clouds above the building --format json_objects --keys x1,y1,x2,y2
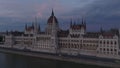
[{"x1": 0, "y1": 0, "x2": 120, "y2": 31}]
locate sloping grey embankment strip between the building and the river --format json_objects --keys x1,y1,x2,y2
[{"x1": 0, "y1": 48, "x2": 120, "y2": 68}]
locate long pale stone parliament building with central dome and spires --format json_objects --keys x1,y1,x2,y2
[{"x1": 2, "y1": 11, "x2": 120, "y2": 59}]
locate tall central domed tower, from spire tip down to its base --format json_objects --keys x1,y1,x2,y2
[{"x1": 46, "y1": 10, "x2": 59, "y2": 53}]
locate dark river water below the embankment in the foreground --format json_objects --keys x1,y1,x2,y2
[{"x1": 0, "y1": 53, "x2": 110, "y2": 68}]
